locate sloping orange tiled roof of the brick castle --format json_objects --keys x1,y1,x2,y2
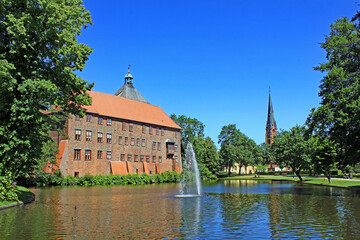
[{"x1": 83, "y1": 91, "x2": 181, "y2": 129}]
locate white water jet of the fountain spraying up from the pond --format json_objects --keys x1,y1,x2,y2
[{"x1": 175, "y1": 142, "x2": 201, "y2": 197}]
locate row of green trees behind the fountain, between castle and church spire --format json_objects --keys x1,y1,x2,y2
[{"x1": 170, "y1": 114, "x2": 264, "y2": 178}]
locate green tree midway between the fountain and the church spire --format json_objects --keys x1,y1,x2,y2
[{"x1": 219, "y1": 124, "x2": 263, "y2": 175}]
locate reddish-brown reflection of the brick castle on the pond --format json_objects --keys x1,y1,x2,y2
[{"x1": 52, "y1": 185, "x2": 182, "y2": 239}]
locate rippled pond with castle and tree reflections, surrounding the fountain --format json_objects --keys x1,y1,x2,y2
[{"x1": 0, "y1": 180, "x2": 360, "y2": 239}]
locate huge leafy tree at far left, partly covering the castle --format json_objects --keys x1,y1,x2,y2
[{"x1": 0, "y1": 0, "x2": 93, "y2": 177}]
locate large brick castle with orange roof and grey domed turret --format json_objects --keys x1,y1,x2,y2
[{"x1": 45, "y1": 70, "x2": 182, "y2": 177}]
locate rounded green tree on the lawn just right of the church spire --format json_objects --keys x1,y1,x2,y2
[{"x1": 269, "y1": 126, "x2": 311, "y2": 182}]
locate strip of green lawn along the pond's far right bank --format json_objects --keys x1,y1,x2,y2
[{"x1": 222, "y1": 175, "x2": 360, "y2": 191}]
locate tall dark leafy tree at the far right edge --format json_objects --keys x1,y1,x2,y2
[{"x1": 307, "y1": 12, "x2": 360, "y2": 168}]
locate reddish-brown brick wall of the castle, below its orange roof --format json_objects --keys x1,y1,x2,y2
[{"x1": 60, "y1": 113, "x2": 181, "y2": 176}]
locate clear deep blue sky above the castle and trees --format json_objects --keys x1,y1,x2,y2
[{"x1": 79, "y1": 0, "x2": 359, "y2": 144}]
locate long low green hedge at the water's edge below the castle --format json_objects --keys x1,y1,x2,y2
[{"x1": 18, "y1": 171, "x2": 180, "y2": 187}]
